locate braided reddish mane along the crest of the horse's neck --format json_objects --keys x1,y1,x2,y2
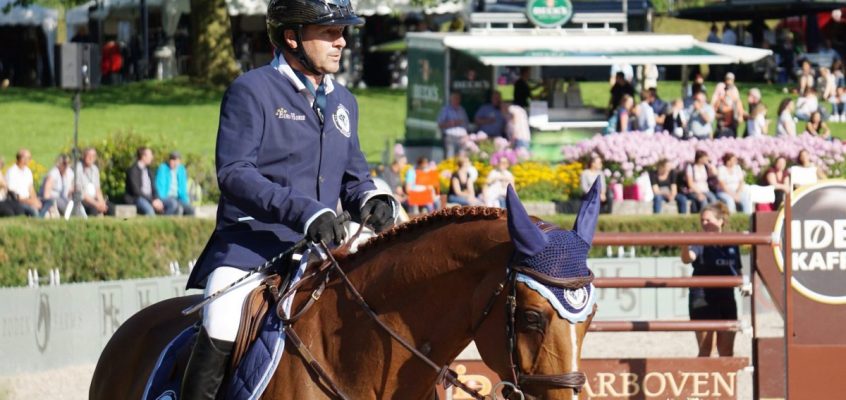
[{"x1": 335, "y1": 206, "x2": 505, "y2": 260}]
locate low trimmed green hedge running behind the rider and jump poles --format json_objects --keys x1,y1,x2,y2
[{"x1": 0, "y1": 215, "x2": 749, "y2": 286}]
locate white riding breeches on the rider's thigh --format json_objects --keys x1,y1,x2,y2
[{"x1": 203, "y1": 267, "x2": 267, "y2": 342}]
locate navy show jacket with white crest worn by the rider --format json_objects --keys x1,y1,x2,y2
[{"x1": 188, "y1": 61, "x2": 382, "y2": 288}]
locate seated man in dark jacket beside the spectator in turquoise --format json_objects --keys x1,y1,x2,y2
[{"x1": 124, "y1": 147, "x2": 164, "y2": 216}]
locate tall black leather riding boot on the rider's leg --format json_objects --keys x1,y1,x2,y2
[{"x1": 179, "y1": 328, "x2": 233, "y2": 400}]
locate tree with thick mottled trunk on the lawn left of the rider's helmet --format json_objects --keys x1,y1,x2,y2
[{"x1": 7, "y1": 0, "x2": 240, "y2": 85}]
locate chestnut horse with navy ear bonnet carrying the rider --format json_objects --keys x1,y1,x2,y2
[{"x1": 89, "y1": 186, "x2": 598, "y2": 400}]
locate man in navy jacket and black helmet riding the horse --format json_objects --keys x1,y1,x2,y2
[{"x1": 180, "y1": 0, "x2": 399, "y2": 400}]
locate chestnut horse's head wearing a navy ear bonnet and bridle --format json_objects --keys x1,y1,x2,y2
[{"x1": 477, "y1": 182, "x2": 599, "y2": 399}]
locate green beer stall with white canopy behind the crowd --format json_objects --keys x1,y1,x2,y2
[{"x1": 405, "y1": 29, "x2": 771, "y2": 158}]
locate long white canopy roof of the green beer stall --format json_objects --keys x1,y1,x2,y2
[{"x1": 438, "y1": 29, "x2": 772, "y2": 66}]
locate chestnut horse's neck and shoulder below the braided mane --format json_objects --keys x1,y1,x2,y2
[{"x1": 274, "y1": 217, "x2": 511, "y2": 398}]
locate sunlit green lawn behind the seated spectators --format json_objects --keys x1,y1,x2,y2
[{"x1": 0, "y1": 78, "x2": 846, "y2": 165}]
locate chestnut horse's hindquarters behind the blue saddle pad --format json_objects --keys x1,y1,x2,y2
[{"x1": 88, "y1": 296, "x2": 199, "y2": 400}]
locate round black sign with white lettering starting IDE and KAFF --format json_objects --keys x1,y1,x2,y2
[{"x1": 773, "y1": 180, "x2": 846, "y2": 304}]
